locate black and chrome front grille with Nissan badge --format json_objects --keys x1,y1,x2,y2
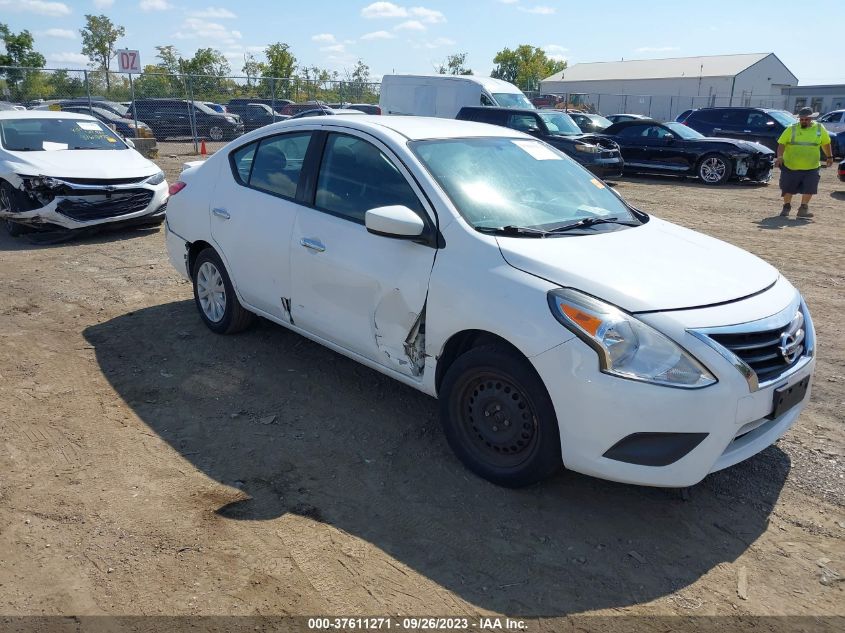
[{"x1": 710, "y1": 311, "x2": 804, "y2": 382}]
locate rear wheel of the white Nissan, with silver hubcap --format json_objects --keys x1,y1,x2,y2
[{"x1": 191, "y1": 248, "x2": 255, "y2": 334}]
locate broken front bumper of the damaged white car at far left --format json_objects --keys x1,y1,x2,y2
[{"x1": 0, "y1": 178, "x2": 168, "y2": 230}]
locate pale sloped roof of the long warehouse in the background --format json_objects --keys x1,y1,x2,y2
[{"x1": 544, "y1": 53, "x2": 774, "y2": 81}]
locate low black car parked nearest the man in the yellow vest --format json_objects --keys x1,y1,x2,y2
[{"x1": 604, "y1": 120, "x2": 775, "y2": 185}]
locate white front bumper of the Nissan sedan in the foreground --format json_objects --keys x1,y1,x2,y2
[{"x1": 531, "y1": 288, "x2": 815, "y2": 487}]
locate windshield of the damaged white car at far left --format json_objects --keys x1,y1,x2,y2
[{"x1": 0, "y1": 119, "x2": 127, "y2": 152}]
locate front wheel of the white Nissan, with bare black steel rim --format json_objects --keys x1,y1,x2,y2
[{"x1": 439, "y1": 345, "x2": 562, "y2": 488}]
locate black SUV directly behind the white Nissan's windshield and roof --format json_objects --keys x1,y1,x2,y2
[{"x1": 456, "y1": 106, "x2": 624, "y2": 178}]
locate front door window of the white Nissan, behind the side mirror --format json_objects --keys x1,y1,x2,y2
[{"x1": 314, "y1": 134, "x2": 424, "y2": 224}]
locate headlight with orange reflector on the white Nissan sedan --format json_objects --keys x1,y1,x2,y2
[{"x1": 548, "y1": 288, "x2": 716, "y2": 389}]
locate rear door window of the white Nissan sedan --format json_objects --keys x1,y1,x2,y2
[{"x1": 249, "y1": 132, "x2": 311, "y2": 198}]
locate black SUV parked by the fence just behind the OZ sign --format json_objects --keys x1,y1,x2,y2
[{"x1": 126, "y1": 99, "x2": 244, "y2": 141}]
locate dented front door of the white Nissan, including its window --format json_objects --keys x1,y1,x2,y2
[{"x1": 290, "y1": 133, "x2": 436, "y2": 376}]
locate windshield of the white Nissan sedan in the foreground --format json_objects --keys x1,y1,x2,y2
[{"x1": 410, "y1": 138, "x2": 637, "y2": 229}]
